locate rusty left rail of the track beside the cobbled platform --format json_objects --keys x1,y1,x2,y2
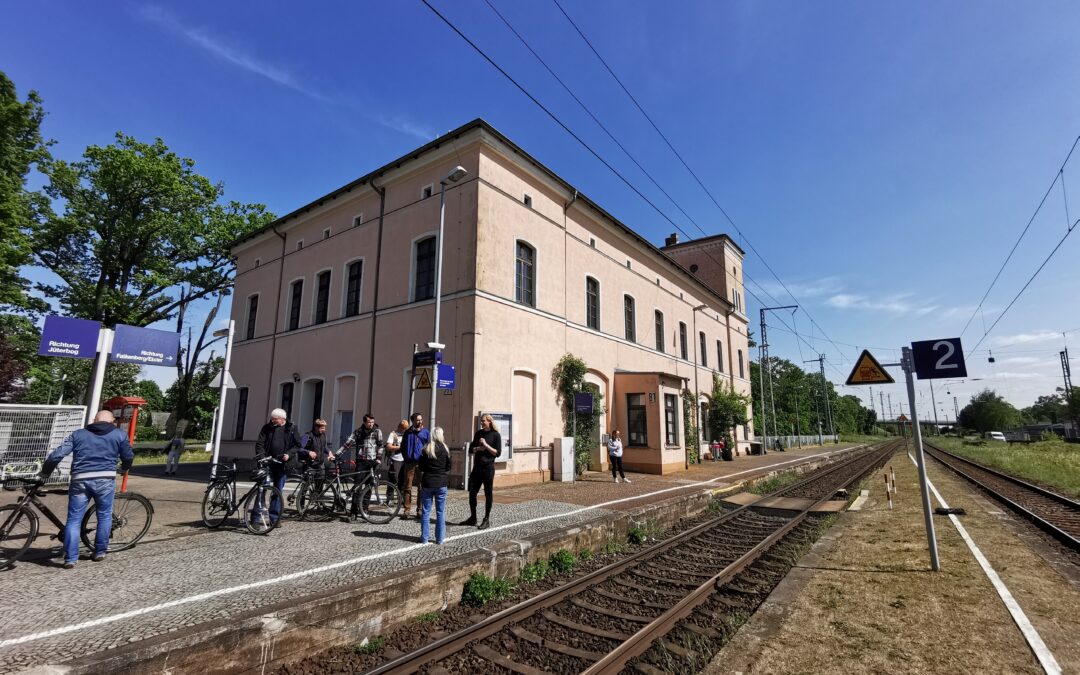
[{"x1": 367, "y1": 436, "x2": 895, "y2": 675}]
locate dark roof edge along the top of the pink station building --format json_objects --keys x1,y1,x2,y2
[{"x1": 229, "y1": 118, "x2": 742, "y2": 309}]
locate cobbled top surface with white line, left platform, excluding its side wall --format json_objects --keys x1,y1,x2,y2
[{"x1": 0, "y1": 446, "x2": 859, "y2": 673}]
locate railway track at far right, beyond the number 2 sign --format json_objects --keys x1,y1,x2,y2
[{"x1": 923, "y1": 443, "x2": 1080, "y2": 552}]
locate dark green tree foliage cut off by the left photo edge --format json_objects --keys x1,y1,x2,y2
[{"x1": 0, "y1": 71, "x2": 51, "y2": 311}]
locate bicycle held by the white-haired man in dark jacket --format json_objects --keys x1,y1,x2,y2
[{"x1": 202, "y1": 457, "x2": 285, "y2": 535}]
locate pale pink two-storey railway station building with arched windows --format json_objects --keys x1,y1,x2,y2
[{"x1": 222, "y1": 120, "x2": 751, "y2": 484}]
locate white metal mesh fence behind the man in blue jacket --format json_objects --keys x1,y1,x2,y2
[{"x1": 0, "y1": 404, "x2": 86, "y2": 484}]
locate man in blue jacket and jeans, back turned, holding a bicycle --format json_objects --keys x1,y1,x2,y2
[{"x1": 41, "y1": 410, "x2": 135, "y2": 569}]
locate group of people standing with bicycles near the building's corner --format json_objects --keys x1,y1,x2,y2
[{"x1": 255, "y1": 408, "x2": 502, "y2": 544}]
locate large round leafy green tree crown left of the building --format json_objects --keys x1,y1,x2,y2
[{"x1": 33, "y1": 133, "x2": 272, "y2": 326}]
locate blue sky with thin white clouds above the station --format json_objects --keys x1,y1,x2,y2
[{"x1": 6, "y1": 0, "x2": 1080, "y2": 416}]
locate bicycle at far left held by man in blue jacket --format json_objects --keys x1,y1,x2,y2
[{"x1": 0, "y1": 473, "x2": 153, "y2": 569}]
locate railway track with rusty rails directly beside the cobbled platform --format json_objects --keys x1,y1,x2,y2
[{"x1": 369, "y1": 442, "x2": 901, "y2": 675}]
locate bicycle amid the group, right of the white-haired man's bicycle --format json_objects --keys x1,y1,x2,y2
[{"x1": 297, "y1": 467, "x2": 402, "y2": 525}]
